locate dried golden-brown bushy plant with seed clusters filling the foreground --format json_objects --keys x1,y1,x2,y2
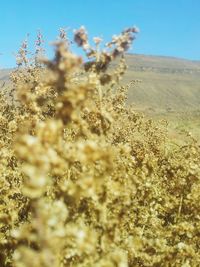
[{"x1": 0, "y1": 27, "x2": 200, "y2": 267}]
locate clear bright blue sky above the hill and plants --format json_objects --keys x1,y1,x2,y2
[{"x1": 0, "y1": 0, "x2": 200, "y2": 68}]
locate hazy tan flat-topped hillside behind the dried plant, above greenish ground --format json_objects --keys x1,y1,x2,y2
[{"x1": 0, "y1": 54, "x2": 200, "y2": 114}]
